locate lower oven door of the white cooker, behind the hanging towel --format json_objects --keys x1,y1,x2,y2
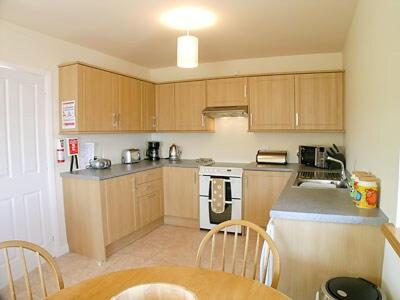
[{"x1": 200, "y1": 196, "x2": 242, "y2": 233}]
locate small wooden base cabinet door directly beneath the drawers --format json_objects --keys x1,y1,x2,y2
[{"x1": 136, "y1": 189, "x2": 164, "y2": 229}]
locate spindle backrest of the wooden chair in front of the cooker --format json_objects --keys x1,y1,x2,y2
[{"x1": 196, "y1": 220, "x2": 280, "y2": 288}]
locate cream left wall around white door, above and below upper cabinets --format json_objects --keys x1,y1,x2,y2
[{"x1": 0, "y1": 20, "x2": 150, "y2": 254}]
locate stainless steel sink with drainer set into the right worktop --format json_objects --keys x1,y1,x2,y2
[{"x1": 293, "y1": 171, "x2": 349, "y2": 189}]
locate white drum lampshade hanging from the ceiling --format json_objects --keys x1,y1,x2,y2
[{"x1": 177, "y1": 35, "x2": 199, "y2": 68}]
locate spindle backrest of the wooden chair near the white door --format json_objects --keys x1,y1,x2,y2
[{"x1": 0, "y1": 240, "x2": 64, "y2": 299}]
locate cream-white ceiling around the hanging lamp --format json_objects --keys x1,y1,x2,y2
[{"x1": 0, "y1": 0, "x2": 357, "y2": 68}]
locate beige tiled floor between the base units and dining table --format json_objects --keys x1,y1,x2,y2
[{"x1": 0, "y1": 225, "x2": 255, "y2": 299}]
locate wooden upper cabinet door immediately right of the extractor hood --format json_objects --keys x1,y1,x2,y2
[{"x1": 249, "y1": 75, "x2": 294, "y2": 130}]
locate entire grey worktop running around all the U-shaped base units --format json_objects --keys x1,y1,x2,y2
[{"x1": 61, "y1": 159, "x2": 388, "y2": 225}]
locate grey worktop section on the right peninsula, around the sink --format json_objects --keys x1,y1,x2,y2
[{"x1": 270, "y1": 170, "x2": 388, "y2": 225}]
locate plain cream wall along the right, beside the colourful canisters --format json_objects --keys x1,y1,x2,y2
[{"x1": 344, "y1": 0, "x2": 400, "y2": 299}]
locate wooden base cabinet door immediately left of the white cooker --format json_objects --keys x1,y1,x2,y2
[{"x1": 163, "y1": 168, "x2": 199, "y2": 219}]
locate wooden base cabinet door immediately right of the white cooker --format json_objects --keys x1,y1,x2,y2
[{"x1": 244, "y1": 171, "x2": 292, "y2": 227}]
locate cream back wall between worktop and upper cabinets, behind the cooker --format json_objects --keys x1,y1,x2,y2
[{"x1": 151, "y1": 118, "x2": 344, "y2": 162}]
